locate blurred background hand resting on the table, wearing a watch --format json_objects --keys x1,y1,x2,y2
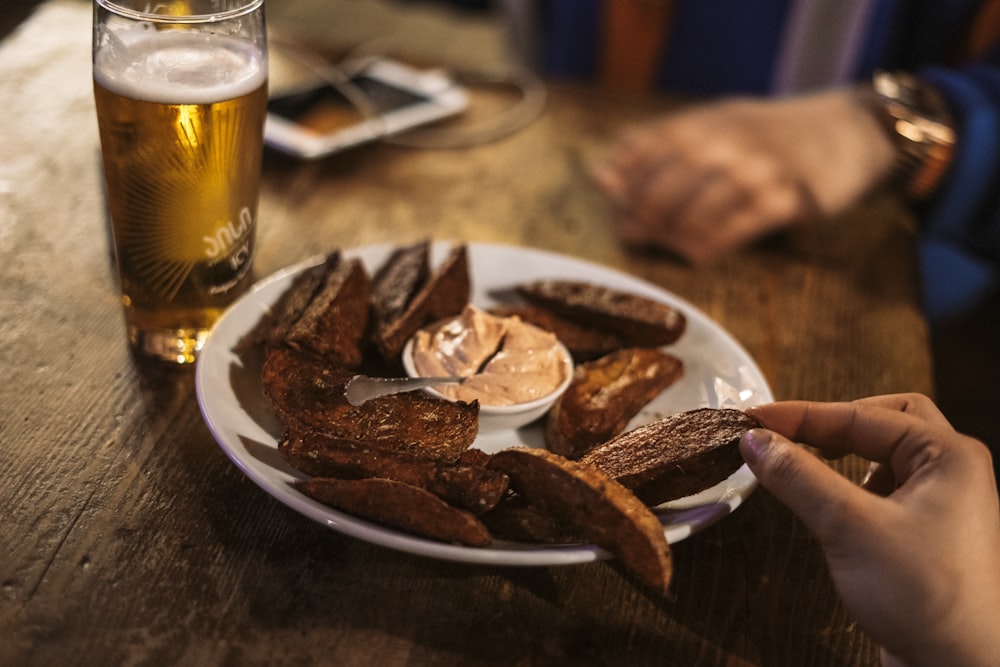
[{"x1": 593, "y1": 89, "x2": 894, "y2": 263}]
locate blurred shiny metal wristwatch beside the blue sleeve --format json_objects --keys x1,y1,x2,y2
[{"x1": 872, "y1": 71, "x2": 955, "y2": 200}]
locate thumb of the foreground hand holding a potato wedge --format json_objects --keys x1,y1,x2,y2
[{"x1": 740, "y1": 428, "x2": 868, "y2": 544}]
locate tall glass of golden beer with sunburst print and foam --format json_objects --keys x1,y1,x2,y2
[{"x1": 93, "y1": 0, "x2": 267, "y2": 364}]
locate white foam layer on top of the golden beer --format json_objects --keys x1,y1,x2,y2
[{"x1": 94, "y1": 31, "x2": 267, "y2": 104}]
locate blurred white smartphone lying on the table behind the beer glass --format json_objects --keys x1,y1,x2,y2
[{"x1": 264, "y1": 58, "x2": 468, "y2": 159}]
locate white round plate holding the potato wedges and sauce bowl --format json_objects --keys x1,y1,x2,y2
[{"x1": 196, "y1": 242, "x2": 773, "y2": 566}]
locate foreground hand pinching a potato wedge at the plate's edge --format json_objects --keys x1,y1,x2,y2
[{"x1": 740, "y1": 394, "x2": 1000, "y2": 665}]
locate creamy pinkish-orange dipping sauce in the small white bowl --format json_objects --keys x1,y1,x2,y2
[{"x1": 413, "y1": 305, "x2": 570, "y2": 405}]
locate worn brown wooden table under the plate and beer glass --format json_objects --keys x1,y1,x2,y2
[{"x1": 0, "y1": 2, "x2": 931, "y2": 665}]
